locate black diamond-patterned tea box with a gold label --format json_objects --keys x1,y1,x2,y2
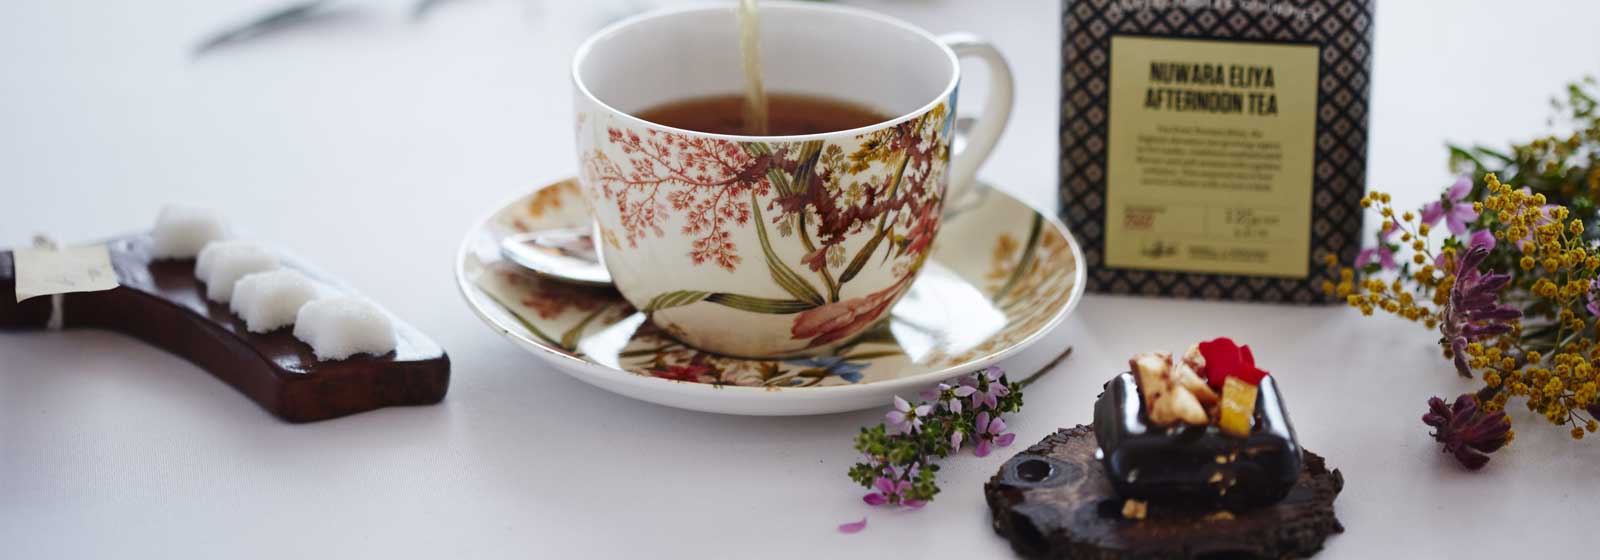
[{"x1": 1059, "y1": 0, "x2": 1373, "y2": 302}]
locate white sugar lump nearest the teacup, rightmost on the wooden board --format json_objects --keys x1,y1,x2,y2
[{"x1": 294, "y1": 296, "x2": 397, "y2": 360}]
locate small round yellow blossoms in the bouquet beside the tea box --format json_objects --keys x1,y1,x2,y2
[{"x1": 1323, "y1": 174, "x2": 1600, "y2": 438}]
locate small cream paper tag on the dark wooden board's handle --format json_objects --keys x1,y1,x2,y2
[{"x1": 13, "y1": 245, "x2": 118, "y2": 302}]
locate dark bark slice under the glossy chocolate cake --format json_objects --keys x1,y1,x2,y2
[{"x1": 984, "y1": 426, "x2": 1344, "y2": 558}]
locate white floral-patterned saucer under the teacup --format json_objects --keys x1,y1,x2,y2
[{"x1": 456, "y1": 179, "x2": 1085, "y2": 416}]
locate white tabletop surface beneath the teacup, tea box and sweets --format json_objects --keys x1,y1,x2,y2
[{"x1": 0, "y1": 0, "x2": 1600, "y2": 558}]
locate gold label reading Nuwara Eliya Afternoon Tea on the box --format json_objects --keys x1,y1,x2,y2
[{"x1": 1106, "y1": 35, "x2": 1318, "y2": 278}]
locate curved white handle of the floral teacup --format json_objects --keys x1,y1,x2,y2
[{"x1": 939, "y1": 34, "x2": 1014, "y2": 208}]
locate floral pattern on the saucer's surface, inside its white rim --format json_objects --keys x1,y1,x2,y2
[{"x1": 469, "y1": 181, "x2": 1078, "y2": 389}]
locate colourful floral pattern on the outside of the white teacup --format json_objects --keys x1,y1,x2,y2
[{"x1": 581, "y1": 102, "x2": 952, "y2": 354}]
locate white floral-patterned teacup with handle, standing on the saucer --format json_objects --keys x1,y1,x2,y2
[{"x1": 573, "y1": 2, "x2": 1011, "y2": 357}]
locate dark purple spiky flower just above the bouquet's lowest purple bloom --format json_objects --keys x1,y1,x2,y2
[{"x1": 1438, "y1": 246, "x2": 1522, "y2": 378}]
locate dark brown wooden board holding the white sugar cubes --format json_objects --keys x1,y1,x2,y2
[{"x1": 0, "y1": 235, "x2": 450, "y2": 422}]
